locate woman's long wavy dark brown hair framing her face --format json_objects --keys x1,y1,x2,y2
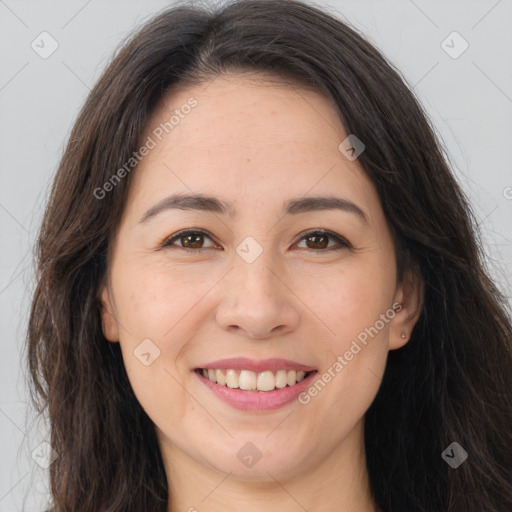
[{"x1": 28, "y1": 0, "x2": 512, "y2": 512}]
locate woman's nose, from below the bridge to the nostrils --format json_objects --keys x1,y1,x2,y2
[{"x1": 216, "y1": 251, "x2": 300, "y2": 339}]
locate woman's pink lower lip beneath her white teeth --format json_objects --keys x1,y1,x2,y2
[{"x1": 194, "y1": 371, "x2": 317, "y2": 411}]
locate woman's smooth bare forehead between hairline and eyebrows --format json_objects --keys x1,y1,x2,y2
[{"x1": 124, "y1": 74, "x2": 377, "y2": 222}]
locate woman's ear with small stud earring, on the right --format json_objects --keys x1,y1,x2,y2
[{"x1": 389, "y1": 271, "x2": 423, "y2": 350}]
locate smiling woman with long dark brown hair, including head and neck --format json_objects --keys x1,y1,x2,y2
[{"x1": 28, "y1": 0, "x2": 512, "y2": 512}]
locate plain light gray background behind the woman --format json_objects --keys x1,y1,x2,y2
[{"x1": 0, "y1": 0, "x2": 512, "y2": 512}]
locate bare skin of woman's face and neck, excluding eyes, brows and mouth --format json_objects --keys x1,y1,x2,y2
[{"x1": 101, "y1": 73, "x2": 422, "y2": 512}]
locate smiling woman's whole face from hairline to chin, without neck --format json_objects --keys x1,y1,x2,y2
[{"x1": 102, "y1": 74, "x2": 418, "y2": 480}]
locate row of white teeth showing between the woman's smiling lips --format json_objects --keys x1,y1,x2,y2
[{"x1": 194, "y1": 368, "x2": 317, "y2": 393}]
